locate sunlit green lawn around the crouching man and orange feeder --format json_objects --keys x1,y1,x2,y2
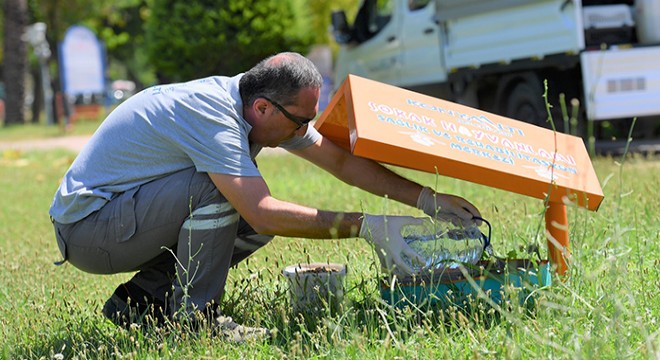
[{"x1": 0, "y1": 151, "x2": 660, "y2": 359}]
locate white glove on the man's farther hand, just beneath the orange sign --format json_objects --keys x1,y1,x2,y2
[{"x1": 417, "y1": 187, "x2": 481, "y2": 226}]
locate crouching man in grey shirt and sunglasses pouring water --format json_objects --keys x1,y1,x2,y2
[{"x1": 50, "y1": 53, "x2": 479, "y2": 341}]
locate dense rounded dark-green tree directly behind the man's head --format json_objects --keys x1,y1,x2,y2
[{"x1": 145, "y1": 0, "x2": 313, "y2": 82}]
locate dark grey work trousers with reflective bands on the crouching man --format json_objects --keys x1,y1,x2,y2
[{"x1": 54, "y1": 168, "x2": 273, "y2": 312}]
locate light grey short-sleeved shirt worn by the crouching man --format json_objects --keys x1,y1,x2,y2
[{"x1": 49, "y1": 74, "x2": 321, "y2": 224}]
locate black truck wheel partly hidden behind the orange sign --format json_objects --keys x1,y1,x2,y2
[{"x1": 505, "y1": 82, "x2": 550, "y2": 128}]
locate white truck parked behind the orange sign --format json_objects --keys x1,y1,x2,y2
[{"x1": 332, "y1": 0, "x2": 660, "y2": 143}]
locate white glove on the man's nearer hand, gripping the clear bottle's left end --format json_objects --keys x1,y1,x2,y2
[{"x1": 360, "y1": 214, "x2": 425, "y2": 276}]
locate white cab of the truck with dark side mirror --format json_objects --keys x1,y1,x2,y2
[{"x1": 334, "y1": 0, "x2": 447, "y2": 95}]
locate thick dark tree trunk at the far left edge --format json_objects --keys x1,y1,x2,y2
[{"x1": 3, "y1": 0, "x2": 28, "y2": 126}]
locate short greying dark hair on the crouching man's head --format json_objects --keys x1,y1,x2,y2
[{"x1": 238, "y1": 52, "x2": 323, "y2": 106}]
